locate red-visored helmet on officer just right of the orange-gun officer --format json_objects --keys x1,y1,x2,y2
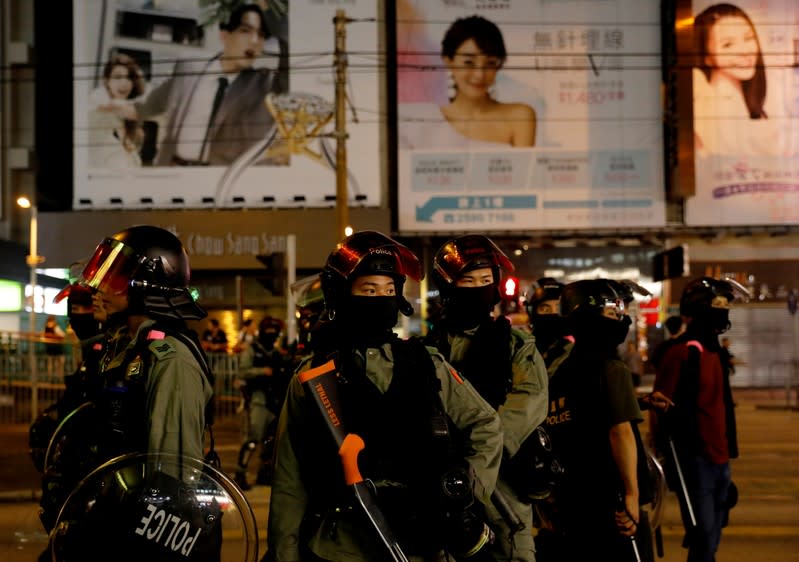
[{"x1": 433, "y1": 234, "x2": 515, "y2": 297}]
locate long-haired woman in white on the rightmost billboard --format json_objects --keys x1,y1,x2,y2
[{"x1": 694, "y1": 4, "x2": 775, "y2": 155}]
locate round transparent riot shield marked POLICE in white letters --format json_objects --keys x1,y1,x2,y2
[{"x1": 50, "y1": 454, "x2": 258, "y2": 562}]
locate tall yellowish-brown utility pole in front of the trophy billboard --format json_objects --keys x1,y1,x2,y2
[{"x1": 333, "y1": 10, "x2": 349, "y2": 242}]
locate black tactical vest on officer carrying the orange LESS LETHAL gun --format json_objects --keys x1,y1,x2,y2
[{"x1": 298, "y1": 339, "x2": 454, "y2": 536}]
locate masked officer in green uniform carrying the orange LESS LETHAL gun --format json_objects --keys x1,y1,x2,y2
[{"x1": 267, "y1": 231, "x2": 502, "y2": 561}]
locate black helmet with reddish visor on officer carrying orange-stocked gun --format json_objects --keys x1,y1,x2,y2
[{"x1": 320, "y1": 230, "x2": 422, "y2": 316}]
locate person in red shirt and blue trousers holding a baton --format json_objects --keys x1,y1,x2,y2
[{"x1": 648, "y1": 277, "x2": 747, "y2": 562}]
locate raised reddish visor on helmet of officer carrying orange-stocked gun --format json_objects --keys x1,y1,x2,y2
[{"x1": 327, "y1": 232, "x2": 422, "y2": 281}]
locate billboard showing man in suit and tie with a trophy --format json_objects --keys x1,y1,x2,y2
[{"x1": 73, "y1": 0, "x2": 381, "y2": 210}]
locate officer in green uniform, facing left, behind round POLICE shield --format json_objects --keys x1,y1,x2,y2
[{"x1": 48, "y1": 226, "x2": 221, "y2": 560}]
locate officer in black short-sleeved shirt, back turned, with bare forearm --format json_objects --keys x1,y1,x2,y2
[{"x1": 536, "y1": 279, "x2": 651, "y2": 561}]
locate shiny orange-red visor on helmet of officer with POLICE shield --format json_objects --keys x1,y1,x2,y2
[{"x1": 77, "y1": 238, "x2": 141, "y2": 295}]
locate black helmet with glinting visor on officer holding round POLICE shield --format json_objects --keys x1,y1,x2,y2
[{"x1": 56, "y1": 225, "x2": 206, "y2": 320}]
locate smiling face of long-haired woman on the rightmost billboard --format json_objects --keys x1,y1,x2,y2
[{"x1": 706, "y1": 17, "x2": 758, "y2": 82}]
